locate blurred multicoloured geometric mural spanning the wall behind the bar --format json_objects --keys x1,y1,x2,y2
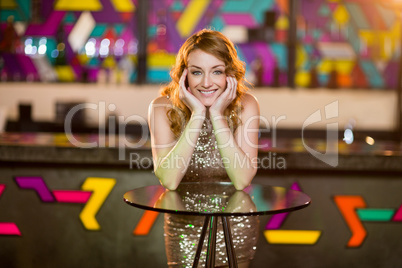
[{"x1": 0, "y1": 0, "x2": 402, "y2": 89}]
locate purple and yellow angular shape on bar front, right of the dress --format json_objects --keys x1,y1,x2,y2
[{"x1": 264, "y1": 182, "x2": 321, "y2": 245}]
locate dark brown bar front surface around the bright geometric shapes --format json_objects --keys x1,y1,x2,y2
[{"x1": 0, "y1": 165, "x2": 402, "y2": 268}]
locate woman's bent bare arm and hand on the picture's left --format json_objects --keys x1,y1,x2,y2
[{"x1": 148, "y1": 70, "x2": 206, "y2": 190}]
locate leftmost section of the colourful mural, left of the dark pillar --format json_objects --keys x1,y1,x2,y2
[{"x1": 0, "y1": 0, "x2": 138, "y2": 82}]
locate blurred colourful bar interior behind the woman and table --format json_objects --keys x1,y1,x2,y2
[{"x1": 0, "y1": 0, "x2": 402, "y2": 267}]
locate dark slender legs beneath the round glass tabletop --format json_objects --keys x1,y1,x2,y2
[{"x1": 193, "y1": 215, "x2": 237, "y2": 268}]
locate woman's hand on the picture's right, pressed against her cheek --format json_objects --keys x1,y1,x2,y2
[{"x1": 209, "y1": 76, "x2": 237, "y2": 116}]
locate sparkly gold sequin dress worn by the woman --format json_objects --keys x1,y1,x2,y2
[{"x1": 164, "y1": 118, "x2": 259, "y2": 267}]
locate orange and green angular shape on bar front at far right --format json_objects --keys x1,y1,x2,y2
[{"x1": 334, "y1": 195, "x2": 402, "y2": 247}]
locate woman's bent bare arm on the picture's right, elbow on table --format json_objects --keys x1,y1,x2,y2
[{"x1": 210, "y1": 80, "x2": 260, "y2": 190}]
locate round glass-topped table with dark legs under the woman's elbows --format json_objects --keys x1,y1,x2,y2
[{"x1": 123, "y1": 182, "x2": 311, "y2": 268}]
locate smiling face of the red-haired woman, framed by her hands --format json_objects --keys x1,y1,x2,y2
[{"x1": 187, "y1": 49, "x2": 226, "y2": 107}]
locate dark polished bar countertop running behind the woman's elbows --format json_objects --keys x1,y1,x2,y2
[{"x1": 0, "y1": 133, "x2": 402, "y2": 172}]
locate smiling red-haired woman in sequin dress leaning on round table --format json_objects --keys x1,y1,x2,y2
[{"x1": 148, "y1": 30, "x2": 259, "y2": 267}]
